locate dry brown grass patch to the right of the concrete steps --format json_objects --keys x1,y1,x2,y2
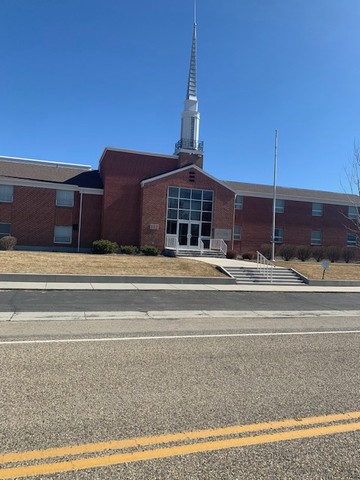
[{"x1": 275, "y1": 260, "x2": 360, "y2": 280}]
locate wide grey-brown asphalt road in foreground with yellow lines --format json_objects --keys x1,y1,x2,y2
[{"x1": 0, "y1": 317, "x2": 360, "y2": 480}]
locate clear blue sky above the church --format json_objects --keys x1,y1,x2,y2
[{"x1": 0, "y1": 0, "x2": 360, "y2": 192}]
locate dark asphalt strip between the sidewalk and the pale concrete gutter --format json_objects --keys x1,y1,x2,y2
[{"x1": 0, "y1": 291, "x2": 360, "y2": 312}]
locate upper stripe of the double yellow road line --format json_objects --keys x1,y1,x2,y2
[{"x1": 0, "y1": 411, "x2": 360, "y2": 464}]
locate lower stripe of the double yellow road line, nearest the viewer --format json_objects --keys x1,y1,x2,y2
[{"x1": 0, "y1": 422, "x2": 360, "y2": 479}]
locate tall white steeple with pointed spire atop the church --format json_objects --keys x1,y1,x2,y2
[{"x1": 175, "y1": 0, "x2": 203, "y2": 153}]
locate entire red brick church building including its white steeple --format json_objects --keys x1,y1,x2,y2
[{"x1": 0, "y1": 16, "x2": 359, "y2": 254}]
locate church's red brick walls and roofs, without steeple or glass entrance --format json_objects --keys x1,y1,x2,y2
[{"x1": 0, "y1": 149, "x2": 358, "y2": 253}]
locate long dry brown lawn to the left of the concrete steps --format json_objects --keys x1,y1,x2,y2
[{"x1": 0, "y1": 251, "x2": 224, "y2": 277}]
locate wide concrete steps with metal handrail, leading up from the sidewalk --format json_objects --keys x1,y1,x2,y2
[{"x1": 221, "y1": 266, "x2": 304, "y2": 285}]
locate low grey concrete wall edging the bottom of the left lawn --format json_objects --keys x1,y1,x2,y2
[{"x1": 0, "y1": 273, "x2": 236, "y2": 285}]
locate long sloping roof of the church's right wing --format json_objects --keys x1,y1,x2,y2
[{"x1": 223, "y1": 181, "x2": 360, "y2": 205}]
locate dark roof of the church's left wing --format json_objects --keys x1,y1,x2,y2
[{"x1": 0, "y1": 157, "x2": 103, "y2": 188}]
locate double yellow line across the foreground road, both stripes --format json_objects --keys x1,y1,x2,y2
[{"x1": 0, "y1": 412, "x2": 360, "y2": 479}]
